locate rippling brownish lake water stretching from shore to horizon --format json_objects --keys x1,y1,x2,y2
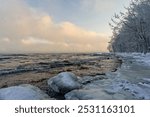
[{"x1": 0, "y1": 53, "x2": 120, "y2": 93}]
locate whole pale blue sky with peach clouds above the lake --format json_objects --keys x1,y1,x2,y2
[{"x1": 0, "y1": 0, "x2": 130, "y2": 53}]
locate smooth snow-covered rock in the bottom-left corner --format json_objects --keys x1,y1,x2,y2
[{"x1": 0, "y1": 84, "x2": 50, "y2": 100}]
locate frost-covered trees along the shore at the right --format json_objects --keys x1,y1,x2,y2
[{"x1": 108, "y1": 0, "x2": 150, "y2": 53}]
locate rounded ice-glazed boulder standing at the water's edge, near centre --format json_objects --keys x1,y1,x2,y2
[{"x1": 48, "y1": 72, "x2": 81, "y2": 94}]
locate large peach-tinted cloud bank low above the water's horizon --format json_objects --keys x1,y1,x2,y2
[{"x1": 0, "y1": 0, "x2": 109, "y2": 53}]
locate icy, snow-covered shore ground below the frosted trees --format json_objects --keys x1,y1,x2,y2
[{"x1": 65, "y1": 53, "x2": 150, "y2": 100}]
